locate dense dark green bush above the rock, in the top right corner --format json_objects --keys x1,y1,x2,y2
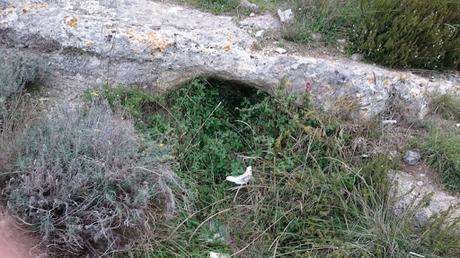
[{"x1": 349, "y1": 0, "x2": 460, "y2": 69}]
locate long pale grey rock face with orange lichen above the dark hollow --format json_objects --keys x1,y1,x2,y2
[{"x1": 0, "y1": 0, "x2": 460, "y2": 118}]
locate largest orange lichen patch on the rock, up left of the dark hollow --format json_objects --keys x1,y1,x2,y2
[{"x1": 125, "y1": 31, "x2": 173, "y2": 54}]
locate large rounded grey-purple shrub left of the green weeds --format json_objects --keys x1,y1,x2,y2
[{"x1": 3, "y1": 102, "x2": 174, "y2": 257}]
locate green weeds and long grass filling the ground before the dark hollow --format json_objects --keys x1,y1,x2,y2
[{"x1": 88, "y1": 80, "x2": 460, "y2": 257}]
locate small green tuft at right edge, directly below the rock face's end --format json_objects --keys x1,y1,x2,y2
[{"x1": 431, "y1": 94, "x2": 460, "y2": 121}]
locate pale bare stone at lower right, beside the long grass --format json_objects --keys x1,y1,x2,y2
[{"x1": 390, "y1": 171, "x2": 460, "y2": 226}]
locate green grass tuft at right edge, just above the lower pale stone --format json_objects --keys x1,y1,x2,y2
[{"x1": 423, "y1": 131, "x2": 460, "y2": 192}]
